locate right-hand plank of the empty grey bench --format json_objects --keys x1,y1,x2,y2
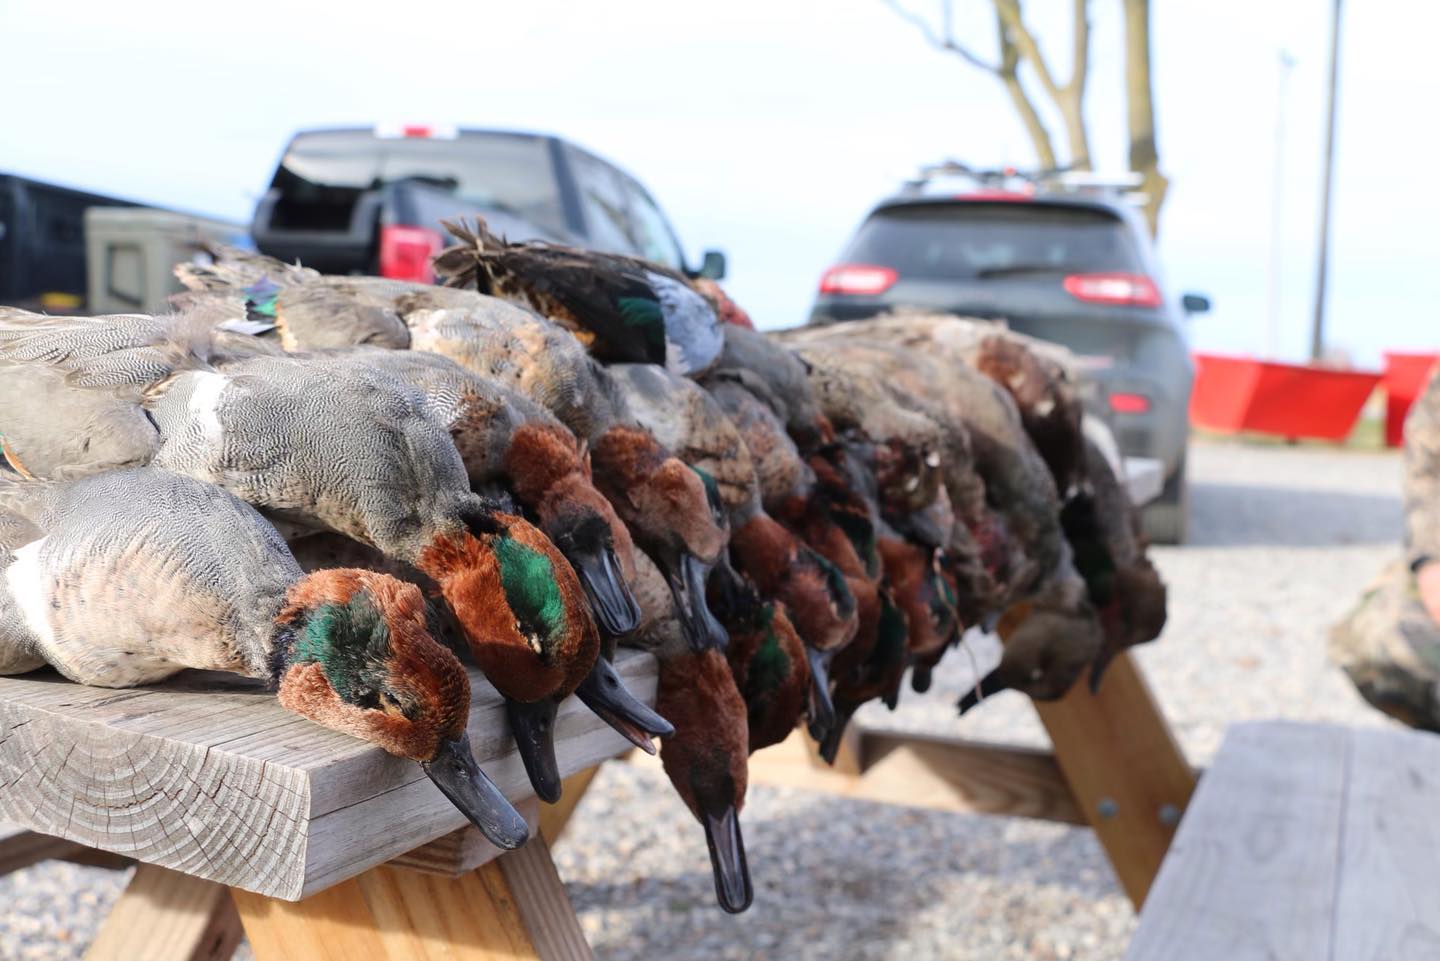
[{"x1": 1329, "y1": 730, "x2": 1440, "y2": 961}]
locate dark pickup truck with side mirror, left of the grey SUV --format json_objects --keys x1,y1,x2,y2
[{"x1": 251, "y1": 125, "x2": 724, "y2": 281}]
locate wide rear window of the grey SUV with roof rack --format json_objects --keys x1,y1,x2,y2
[{"x1": 844, "y1": 202, "x2": 1145, "y2": 280}]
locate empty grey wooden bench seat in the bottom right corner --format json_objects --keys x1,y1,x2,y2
[{"x1": 1125, "y1": 720, "x2": 1440, "y2": 961}]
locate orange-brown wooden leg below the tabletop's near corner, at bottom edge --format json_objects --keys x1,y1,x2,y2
[{"x1": 232, "y1": 837, "x2": 595, "y2": 961}]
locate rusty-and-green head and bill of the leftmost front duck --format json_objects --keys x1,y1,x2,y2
[{"x1": 271, "y1": 569, "x2": 528, "y2": 849}]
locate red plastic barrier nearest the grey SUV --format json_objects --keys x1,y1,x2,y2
[{"x1": 1189, "y1": 354, "x2": 1380, "y2": 441}]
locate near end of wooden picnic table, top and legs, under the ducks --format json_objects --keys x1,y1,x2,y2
[{"x1": 0, "y1": 650, "x2": 657, "y2": 961}]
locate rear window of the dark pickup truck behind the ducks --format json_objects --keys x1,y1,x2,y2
[{"x1": 271, "y1": 130, "x2": 564, "y2": 231}]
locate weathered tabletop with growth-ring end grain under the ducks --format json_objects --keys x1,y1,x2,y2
[{"x1": 0, "y1": 651, "x2": 655, "y2": 899}]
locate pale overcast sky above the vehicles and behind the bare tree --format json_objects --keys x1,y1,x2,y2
[{"x1": 0, "y1": 0, "x2": 1440, "y2": 362}]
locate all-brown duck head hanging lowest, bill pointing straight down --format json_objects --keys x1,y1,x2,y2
[{"x1": 655, "y1": 650, "x2": 753, "y2": 913}]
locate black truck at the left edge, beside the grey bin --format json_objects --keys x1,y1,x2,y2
[{"x1": 0, "y1": 173, "x2": 138, "y2": 310}]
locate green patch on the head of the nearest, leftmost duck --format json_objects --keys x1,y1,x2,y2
[{"x1": 289, "y1": 592, "x2": 390, "y2": 707}]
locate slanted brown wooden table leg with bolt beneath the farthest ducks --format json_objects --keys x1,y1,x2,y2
[{"x1": 1035, "y1": 651, "x2": 1195, "y2": 908}]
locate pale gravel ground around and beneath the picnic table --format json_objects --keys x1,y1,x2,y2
[{"x1": 0, "y1": 444, "x2": 1400, "y2": 961}]
